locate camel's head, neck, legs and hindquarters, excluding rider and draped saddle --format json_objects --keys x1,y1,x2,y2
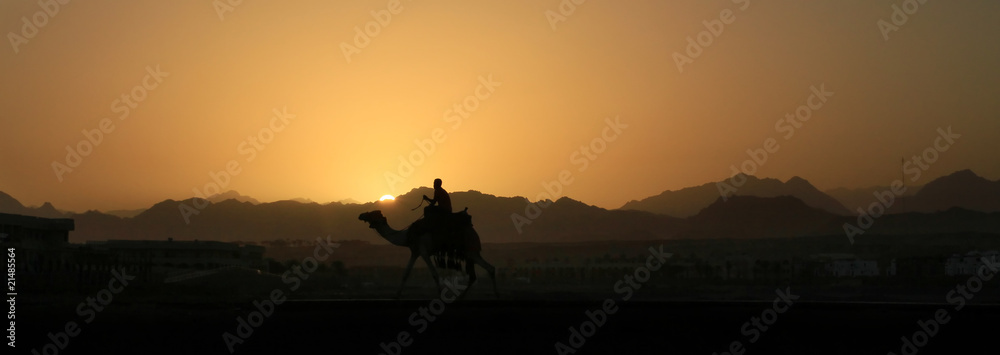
[{"x1": 358, "y1": 208, "x2": 500, "y2": 299}]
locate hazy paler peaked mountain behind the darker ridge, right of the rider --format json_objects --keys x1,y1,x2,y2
[{"x1": 620, "y1": 175, "x2": 851, "y2": 218}]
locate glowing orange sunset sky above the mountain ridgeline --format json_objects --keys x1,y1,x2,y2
[{"x1": 0, "y1": 0, "x2": 1000, "y2": 211}]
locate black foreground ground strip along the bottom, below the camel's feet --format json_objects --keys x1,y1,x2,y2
[{"x1": 15, "y1": 299, "x2": 1000, "y2": 355}]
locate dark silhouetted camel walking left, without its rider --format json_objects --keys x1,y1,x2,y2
[{"x1": 358, "y1": 208, "x2": 500, "y2": 298}]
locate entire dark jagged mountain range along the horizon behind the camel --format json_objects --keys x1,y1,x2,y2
[{"x1": 0, "y1": 170, "x2": 1000, "y2": 243}]
